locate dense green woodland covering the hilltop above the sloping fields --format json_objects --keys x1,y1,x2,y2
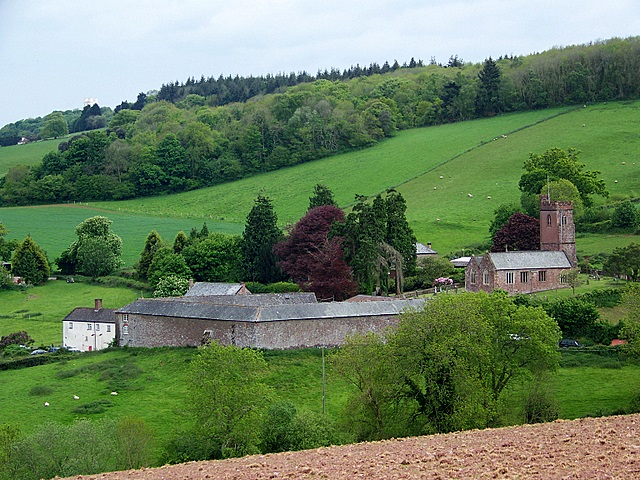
[{"x1": 0, "y1": 37, "x2": 640, "y2": 205}]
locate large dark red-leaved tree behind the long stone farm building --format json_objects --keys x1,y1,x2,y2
[{"x1": 273, "y1": 205, "x2": 358, "y2": 300}]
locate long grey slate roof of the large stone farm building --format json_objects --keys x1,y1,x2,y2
[{"x1": 117, "y1": 299, "x2": 425, "y2": 322}]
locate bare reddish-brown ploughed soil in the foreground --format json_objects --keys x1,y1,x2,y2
[{"x1": 62, "y1": 415, "x2": 640, "y2": 480}]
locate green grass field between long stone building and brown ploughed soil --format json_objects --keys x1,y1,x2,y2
[{"x1": 0, "y1": 348, "x2": 640, "y2": 462}]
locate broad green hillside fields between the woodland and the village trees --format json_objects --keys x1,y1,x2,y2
[{"x1": 0, "y1": 102, "x2": 640, "y2": 265}]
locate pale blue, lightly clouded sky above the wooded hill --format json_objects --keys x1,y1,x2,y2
[{"x1": 0, "y1": 0, "x2": 640, "y2": 127}]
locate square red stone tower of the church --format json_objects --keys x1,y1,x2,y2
[{"x1": 540, "y1": 195, "x2": 578, "y2": 267}]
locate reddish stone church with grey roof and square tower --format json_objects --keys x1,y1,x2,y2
[{"x1": 465, "y1": 195, "x2": 578, "y2": 294}]
